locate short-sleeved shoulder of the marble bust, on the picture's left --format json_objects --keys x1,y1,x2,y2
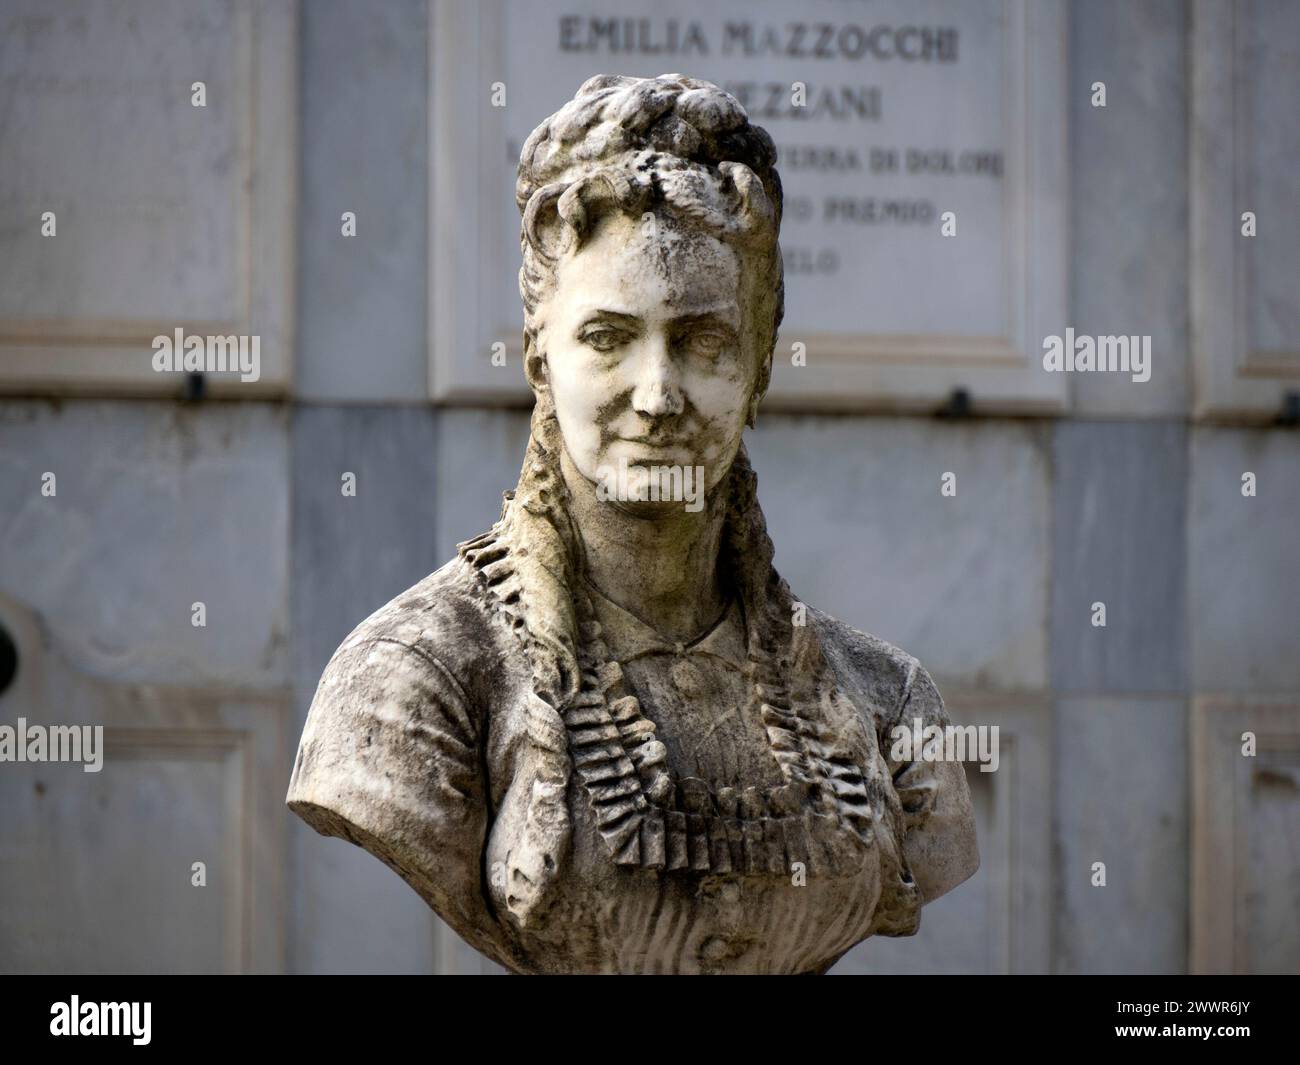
[{"x1": 286, "y1": 558, "x2": 517, "y2": 962}]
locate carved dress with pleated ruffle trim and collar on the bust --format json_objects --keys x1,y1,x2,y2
[{"x1": 289, "y1": 538, "x2": 974, "y2": 973}]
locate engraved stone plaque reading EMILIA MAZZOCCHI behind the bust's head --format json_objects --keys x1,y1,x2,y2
[{"x1": 430, "y1": 1, "x2": 1066, "y2": 408}]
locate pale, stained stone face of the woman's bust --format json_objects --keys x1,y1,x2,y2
[{"x1": 534, "y1": 212, "x2": 761, "y2": 507}]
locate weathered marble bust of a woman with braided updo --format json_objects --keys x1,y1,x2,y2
[{"x1": 287, "y1": 74, "x2": 979, "y2": 973}]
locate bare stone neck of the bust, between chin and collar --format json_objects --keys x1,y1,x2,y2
[{"x1": 560, "y1": 449, "x2": 727, "y2": 641}]
